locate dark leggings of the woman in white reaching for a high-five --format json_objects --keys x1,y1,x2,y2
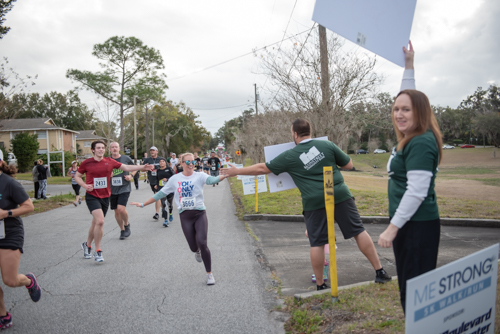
[{"x1": 179, "y1": 210, "x2": 212, "y2": 273}]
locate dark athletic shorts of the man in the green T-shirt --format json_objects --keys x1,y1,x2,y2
[{"x1": 304, "y1": 198, "x2": 365, "y2": 247}]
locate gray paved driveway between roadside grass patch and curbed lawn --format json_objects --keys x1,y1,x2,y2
[{"x1": 247, "y1": 220, "x2": 500, "y2": 296}]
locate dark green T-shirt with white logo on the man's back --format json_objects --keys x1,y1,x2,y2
[{"x1": 266, "y1": 139, "x2": 352, "y2": 211}]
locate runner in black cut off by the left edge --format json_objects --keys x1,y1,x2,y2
[{"x1": 0, "y1": 150, "x2": 41, "y2": 329}]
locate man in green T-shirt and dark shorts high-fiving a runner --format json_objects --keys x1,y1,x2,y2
[{"x1": 222, "y1": 118, "x2": 391, "y2": 290}]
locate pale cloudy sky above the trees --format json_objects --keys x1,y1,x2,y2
[{"x1": 0, "y1": 0, "x2": 500, "y2": 134}]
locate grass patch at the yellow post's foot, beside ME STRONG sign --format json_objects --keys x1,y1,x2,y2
[{"x1": 281, "y1": 264, "x2": 500, "y2": 334}]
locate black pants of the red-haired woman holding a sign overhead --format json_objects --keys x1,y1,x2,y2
[{"x1": 392, "y1": 219, "x2": 441, "y2": 311}]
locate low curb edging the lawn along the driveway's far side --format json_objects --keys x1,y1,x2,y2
[{"x1": 243, "y1": 214, "x2": 500, "y2": 228}]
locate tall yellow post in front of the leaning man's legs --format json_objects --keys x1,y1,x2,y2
[{"x1": 323, "y1": 166, "x2": 339, "y2": 303}]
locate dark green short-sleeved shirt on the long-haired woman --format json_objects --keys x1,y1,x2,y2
[{"x1": 387, "y1": 130, "x2": 439, "y2": 221}]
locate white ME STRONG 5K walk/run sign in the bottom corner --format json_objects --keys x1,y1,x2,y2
[{"x1": 406, "y1": 244, "x2": 500, "y2": 334}]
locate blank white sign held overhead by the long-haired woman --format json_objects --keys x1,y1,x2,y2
[{"x1": 313, "y1": 0, "x2": 417, "y2": 66}]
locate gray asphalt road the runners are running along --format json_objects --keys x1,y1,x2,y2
[{"x1": 6, "y1": 181, "x2": 283, "y2": 334}]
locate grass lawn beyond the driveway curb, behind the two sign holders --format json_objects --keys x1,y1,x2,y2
[{"x1": 229, "y1": 148, "x2": 500, "y2": 219}]
